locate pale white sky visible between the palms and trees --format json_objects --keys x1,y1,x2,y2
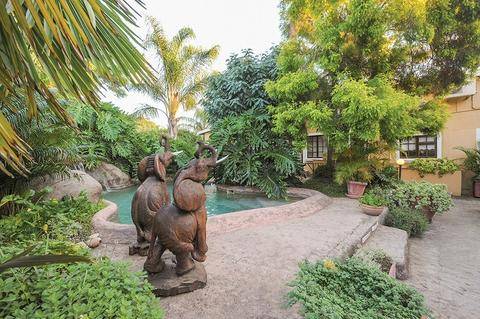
[{"x1": 103, "y1": 0, "x2": 281, "y2": 127}]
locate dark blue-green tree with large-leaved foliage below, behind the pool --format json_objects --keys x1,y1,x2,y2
[{"x1": 203, "y1": 48, "x2": 301, "y2": 197}]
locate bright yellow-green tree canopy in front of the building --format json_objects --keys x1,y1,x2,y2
[{"x1": 266, "y1": 0, "x2": 480, "y2": 163}]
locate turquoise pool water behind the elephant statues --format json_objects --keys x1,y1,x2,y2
[{"x1": 103, "y1": 186, "x2": 295, "y2": 224}]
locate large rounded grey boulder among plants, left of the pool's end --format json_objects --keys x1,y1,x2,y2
[{"x1": 30, "y1": 170, "x2": 102, "y2": 203}]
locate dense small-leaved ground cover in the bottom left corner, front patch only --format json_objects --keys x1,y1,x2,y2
[{"x1": 0, "y1": 259, "x2": 163, "y2": 319}]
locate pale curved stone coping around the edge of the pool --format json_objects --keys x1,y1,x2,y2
[{"x1": 92, "y1": 185, "x2": 332, "y2": 244}]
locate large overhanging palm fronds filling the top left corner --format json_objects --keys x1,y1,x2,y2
[{"x1": 0, "y1": 0, "x2": 153, "y2": 176}]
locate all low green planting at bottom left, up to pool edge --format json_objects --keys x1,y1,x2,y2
[{"x1": 0, "y1": 191, "x2": 163, "y2": 318}]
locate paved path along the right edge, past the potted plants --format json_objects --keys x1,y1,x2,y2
[{"x1": 408, "y1": 199, "x2": 480, "y2": 319}]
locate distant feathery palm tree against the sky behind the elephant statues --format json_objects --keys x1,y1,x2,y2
[{"x1": 134, "y1": 17, "x2": 219, "y2": 138}]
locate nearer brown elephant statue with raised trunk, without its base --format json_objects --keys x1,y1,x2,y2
[{"x1": 144, "y1": 142, "x2": 226, "y2": 276}]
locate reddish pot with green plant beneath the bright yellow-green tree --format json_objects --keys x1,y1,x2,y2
[{"x1": 335, "y1": 161, "x2": 372, "y2": 199}]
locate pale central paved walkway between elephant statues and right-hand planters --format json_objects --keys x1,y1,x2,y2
[{"x1": 96, "y1": 199, "x2": 378, "y2": 319}]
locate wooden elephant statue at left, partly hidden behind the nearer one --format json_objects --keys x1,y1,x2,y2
[{"x1": 129, "y1": 137, "x2": 181, "y2": 255}]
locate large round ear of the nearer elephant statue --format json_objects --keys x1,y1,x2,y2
[{"x1": 173, "y1": 179, "x2": 207, "y2": 212}]
